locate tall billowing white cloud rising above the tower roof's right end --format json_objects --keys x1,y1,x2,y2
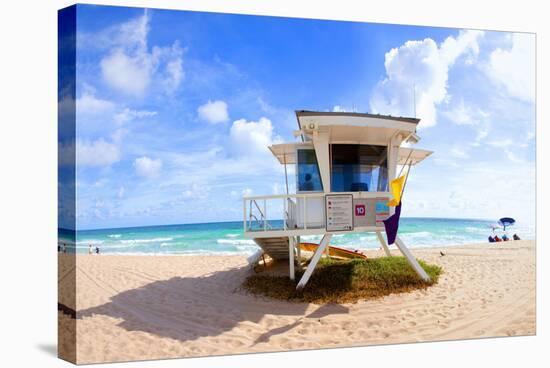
[{"x1": 370, "y1": 31, "x2": 483, "y2": 127}]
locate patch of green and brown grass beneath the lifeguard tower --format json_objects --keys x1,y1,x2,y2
[{"x1": 243, "y1": 257, "x2": 442, "y2": 304}]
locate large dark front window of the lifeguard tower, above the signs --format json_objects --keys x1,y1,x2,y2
[{"x1": 331, "y1": 144, "x2": 388, "y2": 192}]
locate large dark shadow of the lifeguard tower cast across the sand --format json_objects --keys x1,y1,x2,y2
[{"x1": 77, "y1": 268, "x2": 348, "y2": 343}]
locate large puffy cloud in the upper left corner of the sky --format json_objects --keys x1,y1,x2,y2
[{"x1": 98, "y1": 11, "x2": 184, "y2": 96}]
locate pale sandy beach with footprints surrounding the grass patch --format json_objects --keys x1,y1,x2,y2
[{"x1": 59, "y1": 241, "x2": 536, "y2": 363}]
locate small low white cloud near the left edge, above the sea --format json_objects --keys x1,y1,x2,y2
[{"x1": 76, "y1": 138, "x2": 120, "y2": 166}]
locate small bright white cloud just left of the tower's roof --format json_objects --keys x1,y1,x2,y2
[{"x1": 229, "y1": 118, "x2": 279, "y2": 155}]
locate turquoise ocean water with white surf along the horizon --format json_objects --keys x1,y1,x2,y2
[{"x1": 59, "y1": 217, "x2": 535, "y2": 255}]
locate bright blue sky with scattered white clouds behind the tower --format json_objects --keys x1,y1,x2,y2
[{"x1": 60, "y1": 5, "x2": 535, "y2": 229}]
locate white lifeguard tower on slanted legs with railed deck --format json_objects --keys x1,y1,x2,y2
[{"x1": 243, "y1": 111, "x2": 432, "y2": 288}]
